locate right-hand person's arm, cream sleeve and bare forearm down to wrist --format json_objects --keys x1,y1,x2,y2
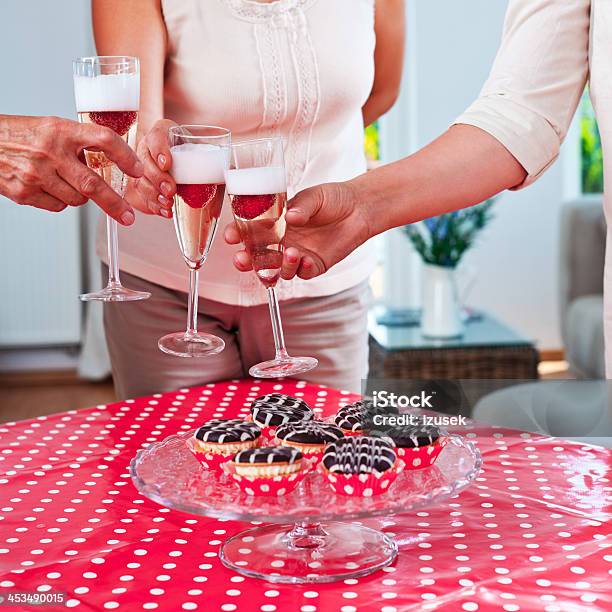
[{"x1": 364, "y1": 0, "x2": 591, "y2": 233}]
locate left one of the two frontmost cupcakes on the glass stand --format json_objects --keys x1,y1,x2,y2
[{"x1": 224, "y1": 446, "x2": 310, "y2": 496}]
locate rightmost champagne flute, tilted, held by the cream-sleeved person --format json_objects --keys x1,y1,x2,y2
[{"x1": 226, "y1": 138, "x2": 319, "y2": 378}]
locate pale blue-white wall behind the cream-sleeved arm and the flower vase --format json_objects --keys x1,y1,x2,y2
[{"x1": 382, "y1": 0, "x2": 563, "y2": 348}]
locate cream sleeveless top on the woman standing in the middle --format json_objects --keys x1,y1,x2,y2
[{"x1": 105, "y1": 0, "x2": 375, "y2": 306}]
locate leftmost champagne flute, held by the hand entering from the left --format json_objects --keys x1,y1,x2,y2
[{"x1": 73, "y1": 56, "x2": 151, "y2": 302}]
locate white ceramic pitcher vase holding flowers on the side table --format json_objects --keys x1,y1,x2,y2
[{"x1": 421, "y1": 264, "x2": 464, "y2": 339}]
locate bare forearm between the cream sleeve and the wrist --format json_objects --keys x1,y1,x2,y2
[{"x1": 348, "y1": 125, "x2": 527, "y2": 236}]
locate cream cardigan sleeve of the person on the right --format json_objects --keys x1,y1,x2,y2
[{"x1": 455, "y1": 0, "x2": 592, "y2": 187}]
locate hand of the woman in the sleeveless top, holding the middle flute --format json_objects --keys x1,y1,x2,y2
[{"x1": 135, "y1": 119, "x2": 176, "y2": 219}]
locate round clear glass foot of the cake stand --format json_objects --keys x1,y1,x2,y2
[{"x1": 220, "y1": 523, "x2": 397, "y2": 584}]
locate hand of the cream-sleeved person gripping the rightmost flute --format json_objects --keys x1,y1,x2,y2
[{"x1": 225, "y1": 183, "x2": 371, "y2": 280}]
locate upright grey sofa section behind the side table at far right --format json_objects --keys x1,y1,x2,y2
[{"x1": 560, "y1": 199, "x2": 606, "y2": 379}]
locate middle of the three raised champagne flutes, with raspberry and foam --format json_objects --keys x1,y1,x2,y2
[{"x1": 158, "y1": 125, "x2": 231, "y2": 357}]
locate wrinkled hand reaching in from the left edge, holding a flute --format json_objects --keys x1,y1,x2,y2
[{"x1": 0, "y1": 115, "x2": 143, "y2": 225}]
